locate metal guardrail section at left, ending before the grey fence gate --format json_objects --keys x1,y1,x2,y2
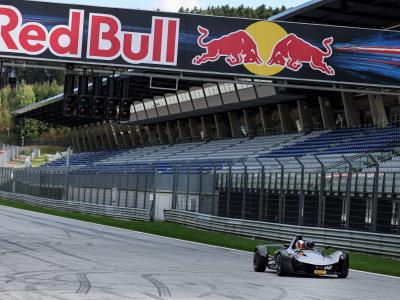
[{"x1": 0, "y1": 191, "x2": 150, "y2": 221}]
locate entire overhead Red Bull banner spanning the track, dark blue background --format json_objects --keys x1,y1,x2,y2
[{"x1": 0, "y1": 0, "x2": 400, "y2": 88}]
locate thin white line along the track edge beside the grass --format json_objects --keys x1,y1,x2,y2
[{"x1": 1, "y1": 205, "x2": 400, "y2": 279}]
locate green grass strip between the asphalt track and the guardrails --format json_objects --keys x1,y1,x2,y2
[{"x1": 0, "y1": 199, "x2": 400, "y2": 276}]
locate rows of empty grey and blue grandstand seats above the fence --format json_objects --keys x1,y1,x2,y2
[{"x1": 45, "y1": 126, "x2": 400, "y2": 172}]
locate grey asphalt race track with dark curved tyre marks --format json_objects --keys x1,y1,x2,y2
[{"x1": 0, "y1": 207, "x2": 400, "y2": 300}]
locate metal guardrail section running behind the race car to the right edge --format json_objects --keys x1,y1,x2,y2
[{"x1": 165, "y1": 210, "x2": 400, "y2": 257}]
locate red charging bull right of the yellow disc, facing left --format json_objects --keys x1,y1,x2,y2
[{"x1": 267, "y1": 33, "x2": 335, "y2": 76}]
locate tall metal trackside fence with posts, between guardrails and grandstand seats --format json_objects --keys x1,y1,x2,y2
[{"x1": 0, "y1": 162, "x2": 400, "y2": 234}]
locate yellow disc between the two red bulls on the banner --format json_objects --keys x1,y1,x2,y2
[{"x1": 244, "y1": 21, "x2": 288, "y2": 76}]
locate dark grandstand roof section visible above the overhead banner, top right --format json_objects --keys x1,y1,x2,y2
[{"x1": 269, "y1": 0, "x2": 400, "y2": 29}]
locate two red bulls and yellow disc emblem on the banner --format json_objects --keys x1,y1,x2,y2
[{"x1": 192, "y1": 21, "x2": 335, "y2": 76}]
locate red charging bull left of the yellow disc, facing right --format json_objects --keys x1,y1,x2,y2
[{"x1": 192, "y1": 26, "x2": 263, "y2": 67}]
